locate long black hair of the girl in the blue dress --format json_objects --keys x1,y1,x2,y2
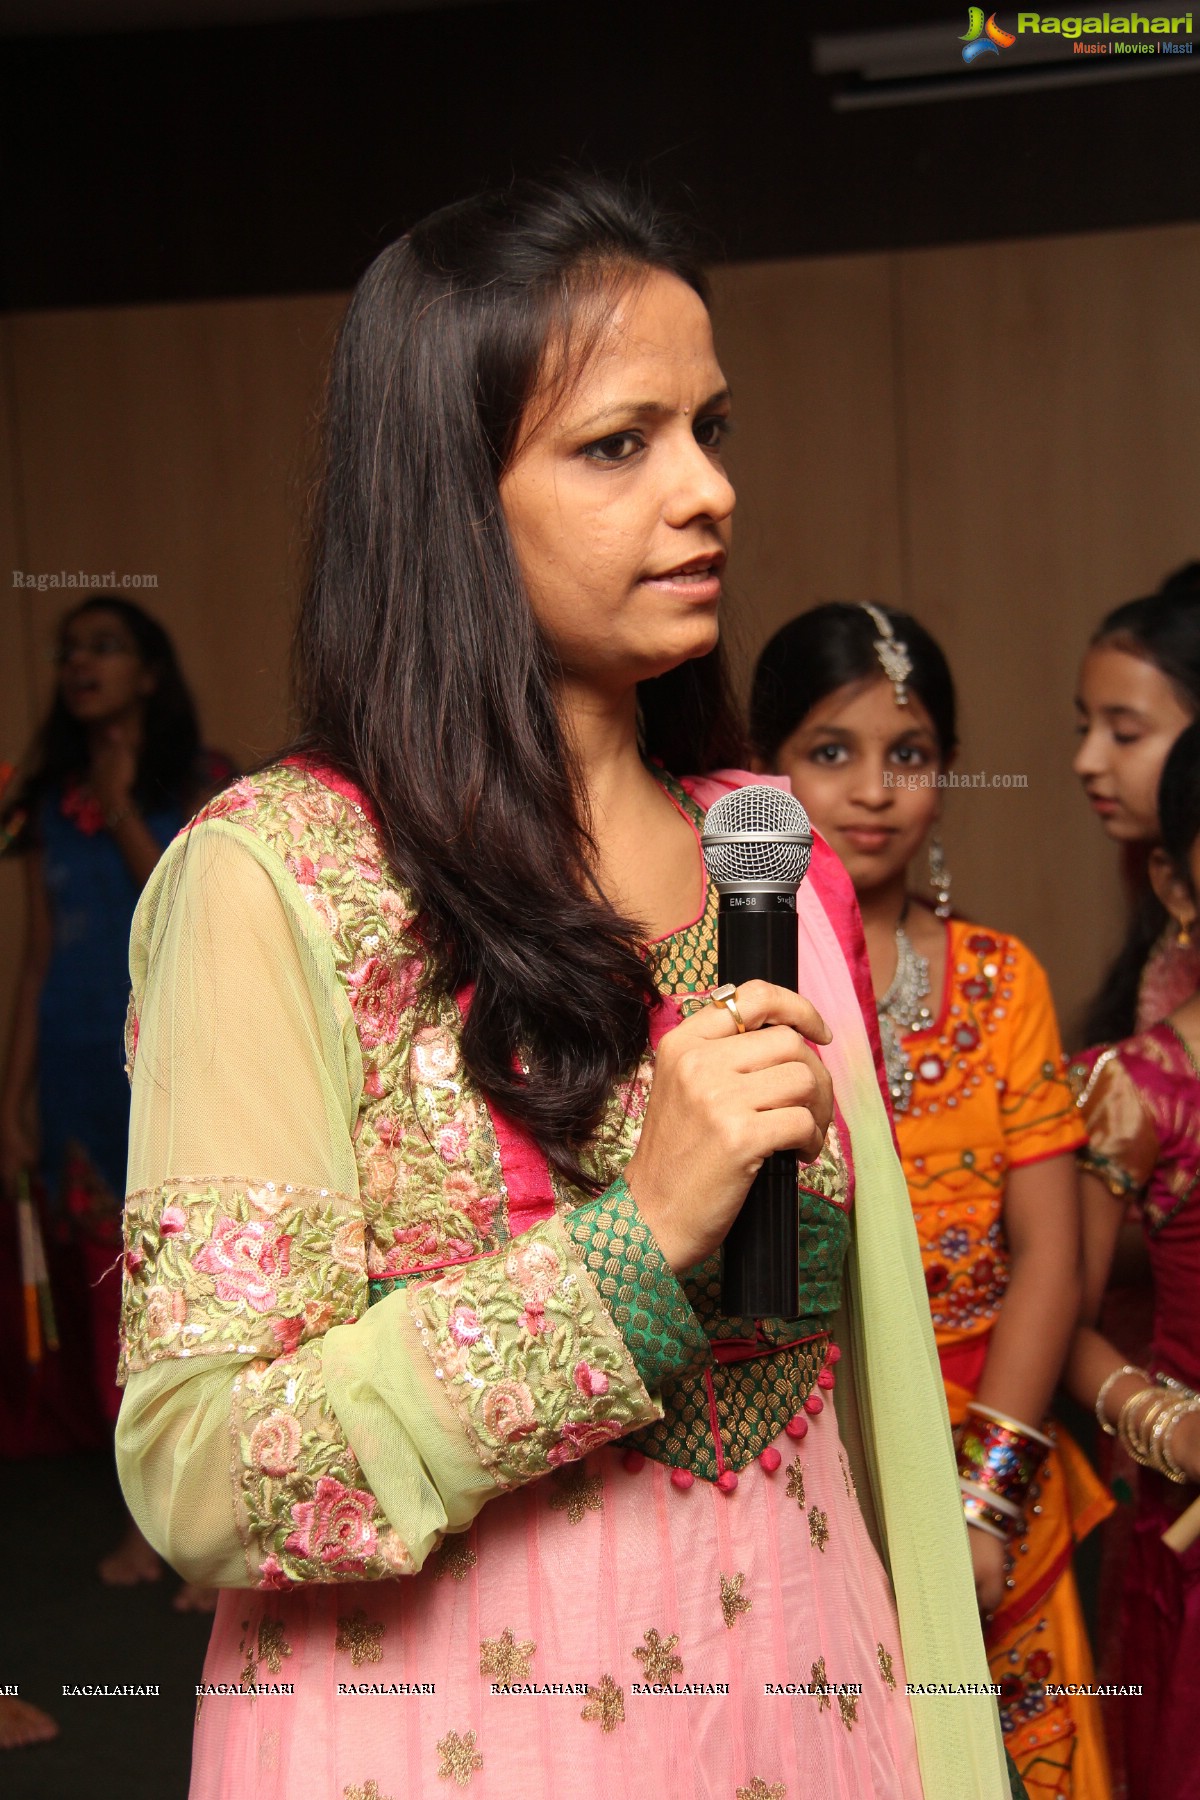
[{"x1": 0, "y1": 590, "x2": 200, "y2": 851}]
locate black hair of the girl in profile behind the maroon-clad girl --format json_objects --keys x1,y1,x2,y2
[{"x1": 1083, "y1": 583, "x2": 1200, "y2": 1044}]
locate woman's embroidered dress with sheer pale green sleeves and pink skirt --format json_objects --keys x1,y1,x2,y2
[{"x1": 119, "y1": 765, "x2": 1006, "y2": 1800}]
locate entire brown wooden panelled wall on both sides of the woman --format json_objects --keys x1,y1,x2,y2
[{"x1": 0, "y1": 227, "x2": 1200, "y2": 1065}]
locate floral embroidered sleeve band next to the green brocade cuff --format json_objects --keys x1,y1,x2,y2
[{"x1": 413, "y1": 1219, "x2": 657, "y2": 1489}]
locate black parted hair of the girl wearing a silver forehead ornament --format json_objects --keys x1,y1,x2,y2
[{"x1": 750, "y1": 599, "x2": 959, "y2": 763}]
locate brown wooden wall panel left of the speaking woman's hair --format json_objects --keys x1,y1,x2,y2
[{"x1": 13, "y1": 297, "x2": 344, "y2": 761}]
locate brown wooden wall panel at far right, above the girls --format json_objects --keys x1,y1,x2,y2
[{"x1": 896, "y1": 227, "x2": 1200, "y2": 1024}]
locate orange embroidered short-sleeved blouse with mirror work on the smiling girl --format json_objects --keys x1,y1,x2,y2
[{"x1": 896, "y1": 918, "x2": 1085, "y2": 1350}]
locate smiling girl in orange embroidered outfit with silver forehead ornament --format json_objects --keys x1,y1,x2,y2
[{"x1": 752, "y1": 603, "x2": 1112, "y2": 1800}]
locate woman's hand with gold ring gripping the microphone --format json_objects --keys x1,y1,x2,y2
[{"x1": 624, "y1": 981, "x2": 833, "y2": 1274}]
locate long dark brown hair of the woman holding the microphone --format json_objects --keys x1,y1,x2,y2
[{"x1": 295, "y1": 176, "x2": 741, "y2": 1183}]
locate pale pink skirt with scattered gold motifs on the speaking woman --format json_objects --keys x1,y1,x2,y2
[{"x1": 191, "y1": 1406, "x2": 921, "y2": 1800}]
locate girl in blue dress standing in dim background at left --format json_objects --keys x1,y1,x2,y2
[{"x1": 0, "y1": 592, "x2": 230, "y2": 1586}]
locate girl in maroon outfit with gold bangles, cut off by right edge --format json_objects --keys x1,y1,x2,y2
[{"x1": 1067, "y1": 724, "x2": 1200, "y2": 1800}]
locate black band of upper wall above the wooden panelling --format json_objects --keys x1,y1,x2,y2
[{"x1": 0, "y1": 0, "x2": 1200, "y2": 310}]
